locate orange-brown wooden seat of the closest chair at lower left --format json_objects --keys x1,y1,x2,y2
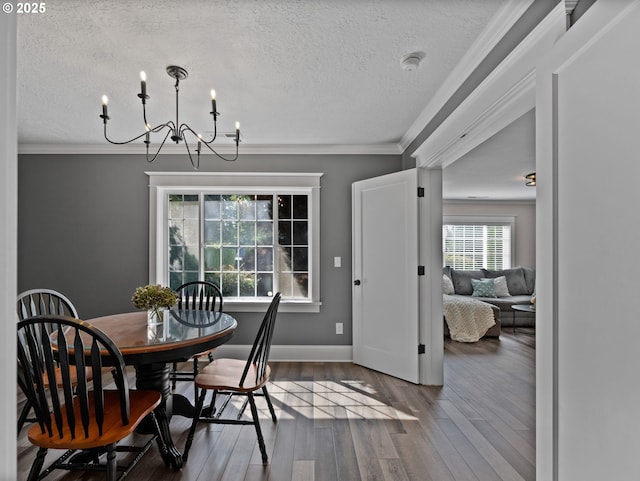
[{"x1": 29, "y1": 390, "x2": 161, "y2": 449}]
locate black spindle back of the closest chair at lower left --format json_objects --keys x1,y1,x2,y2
[{"x1": 18, "y1": 315, "x2": 129, "y2": 438}]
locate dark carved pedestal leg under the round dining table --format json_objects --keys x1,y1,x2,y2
[{"x1": 135, "y1": 363, "x2": 182, "y2": 469}]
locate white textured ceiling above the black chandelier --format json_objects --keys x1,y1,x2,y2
[{"x1": 18, "y1": 0, "x2": 535, "y2": 197}]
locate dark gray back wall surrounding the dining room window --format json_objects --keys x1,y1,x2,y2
[{"x1": 18, "y1": 155, "x2": 402, "y2": 345}]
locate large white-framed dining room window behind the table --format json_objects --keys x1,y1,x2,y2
[{"x1": 148, "y1": 173, "x2": 320, "y2": 312}]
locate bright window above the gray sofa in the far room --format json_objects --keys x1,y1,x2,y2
[{"x1": 442, "y1": 216, "x2": 514, "y2": 270}]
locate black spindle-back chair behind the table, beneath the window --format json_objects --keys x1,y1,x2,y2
[{"x1": 169, "y1": 281, "x2": 223, "y2": 396}]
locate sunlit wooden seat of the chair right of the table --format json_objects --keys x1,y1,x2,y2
[{"x1": 196, "y1": 359, "x2": 271, "y2": 392}]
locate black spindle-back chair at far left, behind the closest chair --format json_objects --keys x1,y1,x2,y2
[{"x1": 16, "y1": 289, "x2": 78, "y2": 433}]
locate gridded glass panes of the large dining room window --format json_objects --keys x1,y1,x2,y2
[{"x1": 167, "y1": 193, "x2": 310, "y2": 298}]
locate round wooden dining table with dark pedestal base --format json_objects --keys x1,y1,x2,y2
[{"x1": 86, "y1": 309, "x2": 237, "y2": 469}]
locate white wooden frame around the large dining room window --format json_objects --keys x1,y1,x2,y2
[{"x1": 145, "y1": 172, "x2": 323, "y2": 312}]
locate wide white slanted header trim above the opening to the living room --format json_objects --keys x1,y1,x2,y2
[{"x1": 413, "y1": 2, "x2": 566, "y2": 167}]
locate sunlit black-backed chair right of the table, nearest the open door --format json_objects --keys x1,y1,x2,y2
[{"x1": 183, "y1": 292, "x2": 281, "y2": 464}]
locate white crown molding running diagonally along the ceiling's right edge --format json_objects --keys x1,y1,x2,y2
[{"x1": 400, "y1": 0, "x2": 534, "y2": 152}]
